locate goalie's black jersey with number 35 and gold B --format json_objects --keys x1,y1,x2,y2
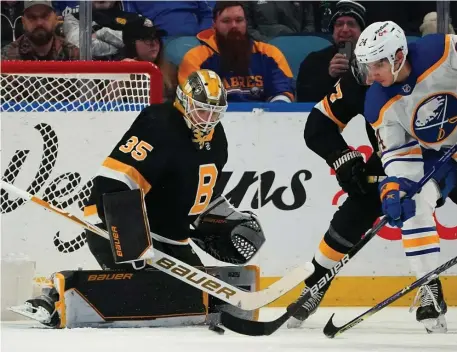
[{"x1": 84, "y1": 103, "x2": 228, "y2": 242}]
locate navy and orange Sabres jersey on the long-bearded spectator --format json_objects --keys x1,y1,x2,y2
[{"x1": 178, "y1": 29, "x2": 294, "y2": 102}]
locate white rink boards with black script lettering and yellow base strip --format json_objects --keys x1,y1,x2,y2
[{"x1": 1, "y1": 104, "x2": 457, "y2": 305}]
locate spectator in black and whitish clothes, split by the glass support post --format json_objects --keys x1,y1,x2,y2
[{"x1": 63, "y1": 1, "x2": 124, "y2": 60}]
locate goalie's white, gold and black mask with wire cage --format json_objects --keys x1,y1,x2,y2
[{"x1": 175, "y1": 70, "x2": 227, "y2": 148}]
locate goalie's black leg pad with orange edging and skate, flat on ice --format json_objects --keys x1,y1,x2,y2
[{"x1": 17, "y1": 266, "x2": 259, "y2": 328}]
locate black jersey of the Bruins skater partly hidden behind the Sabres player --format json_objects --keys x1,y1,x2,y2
[{"x1": 305, "y1": 71, "x2": 382, "y2": 166}]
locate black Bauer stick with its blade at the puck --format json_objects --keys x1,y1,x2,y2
[{"x1": 221, "y1": 145, "x2": 457, "y2": 336}]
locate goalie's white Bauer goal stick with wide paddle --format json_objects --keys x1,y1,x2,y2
[{"x1": 1, "y1": 180, "x2": 314, "y2": 310}]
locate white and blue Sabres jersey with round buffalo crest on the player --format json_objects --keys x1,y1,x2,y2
[{"x1": 364, "y1": 34, "x2": 457, "y2": 181}]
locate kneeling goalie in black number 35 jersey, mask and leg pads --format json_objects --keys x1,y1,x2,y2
[{"x1": 8, "y1": 70, "x2": 265, "y2": 328}]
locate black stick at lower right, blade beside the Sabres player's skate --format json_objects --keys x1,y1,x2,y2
[{"x1": 324, "y1": 253, "x2": 457, "y2": 338}]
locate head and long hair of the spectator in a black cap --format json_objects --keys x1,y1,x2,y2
[{"x1": 122, "y1": 17, "x2": 178, "y2": 101}]
